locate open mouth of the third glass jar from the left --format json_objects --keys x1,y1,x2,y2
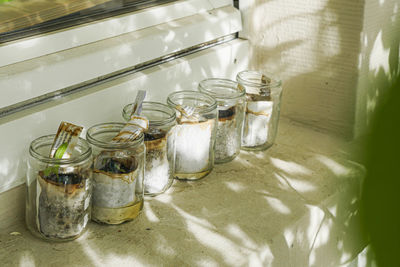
[{"x1": 122, "y1": 101, "x2": 176, "y2": 126}]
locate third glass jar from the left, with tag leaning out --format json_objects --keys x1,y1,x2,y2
[{"x1": 122, "y1": 101, "x2": 176, "y2": 196}]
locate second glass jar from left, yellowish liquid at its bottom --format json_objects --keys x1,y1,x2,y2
[{"x1": 86, "y1": 122, "x2": 145, "y2": 224}]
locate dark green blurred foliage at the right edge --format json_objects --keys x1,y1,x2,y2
[{"x1": 362, "y1": 74, "x2": 400, "y2": 267}]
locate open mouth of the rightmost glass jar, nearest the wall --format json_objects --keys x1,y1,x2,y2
[{"x1": 236, "y1": 70, "x2": 282, "y2": 88}]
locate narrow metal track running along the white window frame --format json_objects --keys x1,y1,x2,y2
[{"x1": 0, "y1": 33, "x2": 238, "y2": 120}]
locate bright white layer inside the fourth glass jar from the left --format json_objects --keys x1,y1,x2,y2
[{"x1": 175, "y1": 120, "x2": 214, "y2": 173}]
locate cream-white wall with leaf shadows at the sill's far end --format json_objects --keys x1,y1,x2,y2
[{"x1": 240, "y1": 0, "x2": 400, "y2": 137}]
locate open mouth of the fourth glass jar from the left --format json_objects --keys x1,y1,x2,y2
[{"x1": 167, "y1": 91, "x2": 217, "y2": 113}]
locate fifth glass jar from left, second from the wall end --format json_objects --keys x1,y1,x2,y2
[{"x1": 199, "y1": 78, "x2": 246, "y2": 163}]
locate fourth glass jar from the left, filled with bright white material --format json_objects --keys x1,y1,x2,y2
[{"x1": 167, "y1": 91, "x2": 218, "y2": 180}]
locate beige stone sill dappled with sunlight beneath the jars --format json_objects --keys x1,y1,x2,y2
[{"x1": 0, "y1": 119, "x2": 365, "y2": 266}]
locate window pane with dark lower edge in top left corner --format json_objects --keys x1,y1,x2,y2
[{"x1": 0, "y1": 0, "x2": 176, "y2": 43}]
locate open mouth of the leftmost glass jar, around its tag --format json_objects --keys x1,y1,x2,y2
[{"x1": 29, "y1": 134, "x2": 92, "y2": 165}]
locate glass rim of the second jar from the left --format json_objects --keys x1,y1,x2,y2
[{"x1": 86, "y1": 122, "x2": 144, "y2": 149}]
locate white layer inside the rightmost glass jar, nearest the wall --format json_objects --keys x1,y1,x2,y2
[{"x1": 242, "y1": 101, "x2": 273, "y2": 147}]
